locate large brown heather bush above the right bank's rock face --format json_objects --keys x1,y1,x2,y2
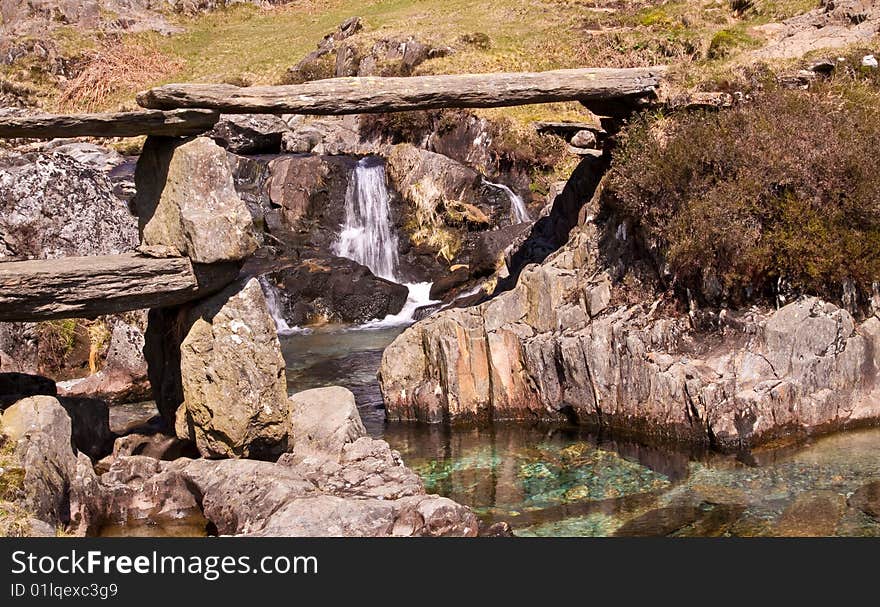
[{"x1": 605, "y1": 82, "x2": 880, "y2": 304}]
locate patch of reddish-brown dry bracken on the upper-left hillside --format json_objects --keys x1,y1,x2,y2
[{"x1": 59, "y1": 43, "x2": 181, "y2": 111}]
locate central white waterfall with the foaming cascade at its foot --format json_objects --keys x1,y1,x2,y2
[{"x1": 332, "y1": 156, "x2": 435, "y2": 329}]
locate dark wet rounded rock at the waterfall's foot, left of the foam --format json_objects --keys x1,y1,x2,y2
[{"x1": 270, "y1": 257, "x2": 409, "y2": 325}]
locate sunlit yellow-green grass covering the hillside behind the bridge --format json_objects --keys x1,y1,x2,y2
[{"x1": 13, "y1": 0, "x2": 818, "y2": 121}]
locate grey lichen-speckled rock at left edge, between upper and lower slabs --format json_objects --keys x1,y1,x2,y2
[{"x1": 0, "y1": 153, "x2": 138, "y2": 259}]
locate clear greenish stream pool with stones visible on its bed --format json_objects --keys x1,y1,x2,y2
[{"x1": 281, "y1": 327, "x2": 880, "y2": 536}]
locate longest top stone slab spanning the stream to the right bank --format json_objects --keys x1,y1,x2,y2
[{"x1": 137, "y1": 66, "x2": 666, "y2": 114}]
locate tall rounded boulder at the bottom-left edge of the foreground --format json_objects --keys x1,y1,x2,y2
[{"x1": 2, "y1": 396, "x2": 76, "y2": 526}]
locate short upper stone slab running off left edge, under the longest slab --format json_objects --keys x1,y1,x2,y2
[{"x1": 0, "y1": 109, "x2": 220, "y2": 139}]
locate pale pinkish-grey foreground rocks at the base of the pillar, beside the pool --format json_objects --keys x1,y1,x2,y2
[{"x1": 71, "y1": 388, "x2": 477, "y2": 536}]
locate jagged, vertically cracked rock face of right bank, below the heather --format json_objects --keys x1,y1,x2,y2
[{"x1": 380, "y1": 223, "x2": 880, "y2": 447}]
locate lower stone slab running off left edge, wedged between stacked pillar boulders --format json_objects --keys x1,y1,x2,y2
[{"x1": 0, "y1": 253, "x2": 239, "y2": 321}]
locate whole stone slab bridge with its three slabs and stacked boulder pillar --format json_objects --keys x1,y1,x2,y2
[{"x1": 0, "y1": 66, "x2": 665, "y2": 442}]
